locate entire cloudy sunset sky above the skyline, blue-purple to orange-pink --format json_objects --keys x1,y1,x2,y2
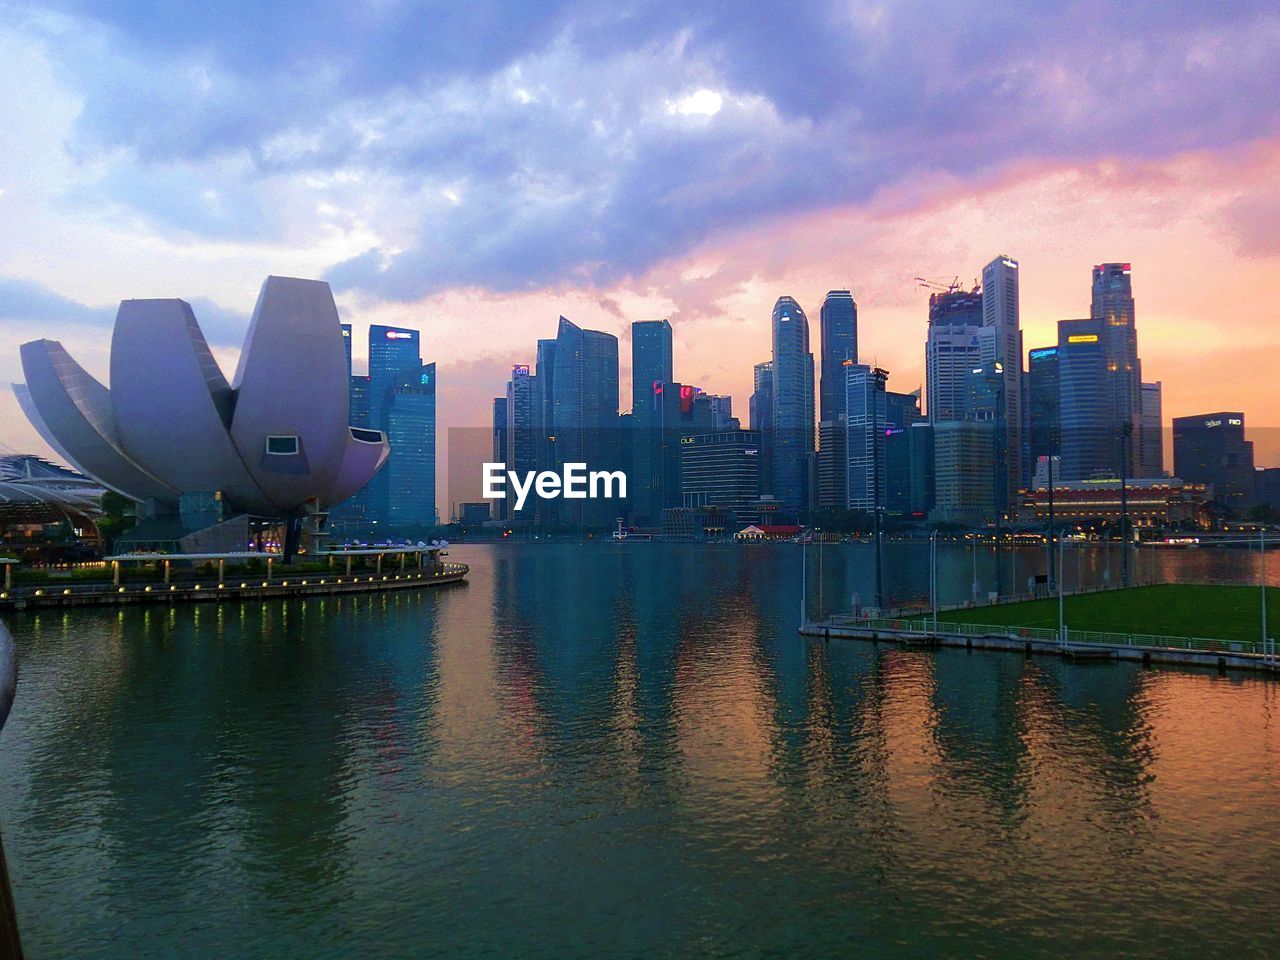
[{"x1": 0, "y1": 0, "x2": 1280, "y2": 507}]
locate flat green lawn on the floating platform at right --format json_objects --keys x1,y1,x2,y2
[{"x1": 938, "y1": 584, "x2": 1280, "y2": 640}]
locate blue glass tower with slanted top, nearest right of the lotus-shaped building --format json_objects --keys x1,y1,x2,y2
[{"x1": 383, "y1": 364, "x2": 436, "y2": 526}]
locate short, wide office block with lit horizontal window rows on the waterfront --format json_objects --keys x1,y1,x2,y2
[{"x1": 680, "y1": 430, "x2": 760, "y2": 525}]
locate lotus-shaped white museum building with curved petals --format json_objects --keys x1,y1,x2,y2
[{"x1": 14, "y1": 276, "x2": 389, "y2": 552}]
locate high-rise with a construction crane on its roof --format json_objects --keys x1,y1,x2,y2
[{"x1": 924, "y1": 289, "x2": 995, "y2": 424}]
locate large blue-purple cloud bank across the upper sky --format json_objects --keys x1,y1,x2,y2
[{"x1": 22, "y1": 0, "x2": 1280, "y2": 300}]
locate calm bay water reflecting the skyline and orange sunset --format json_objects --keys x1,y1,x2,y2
[{"x1": 0, "y1": 544, "x2": 1280, "y2": 960}]
